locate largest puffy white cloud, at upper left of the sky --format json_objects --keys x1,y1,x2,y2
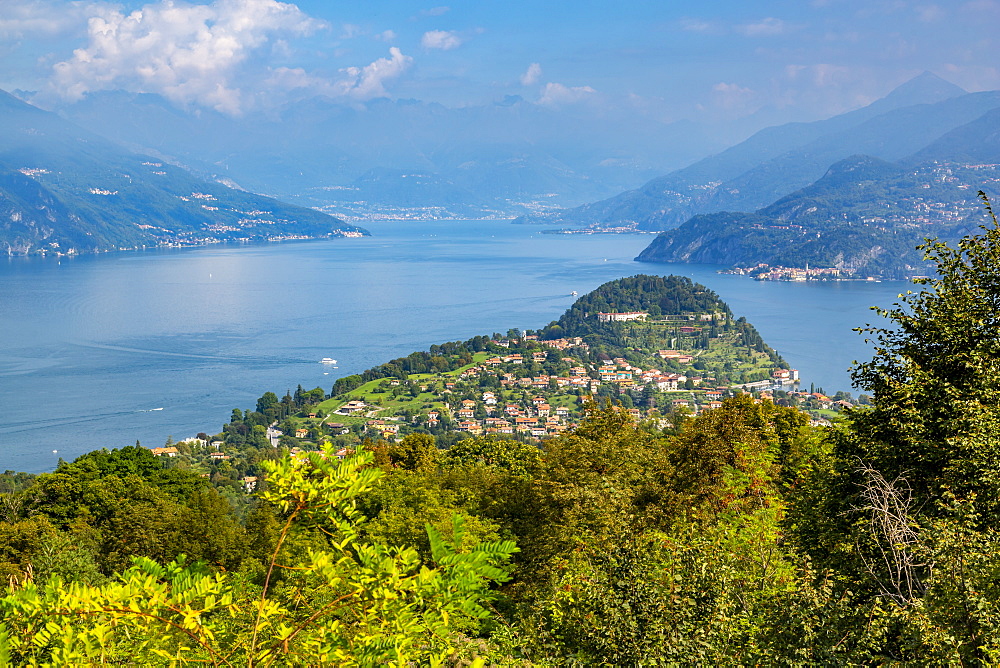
[{"x1": 50, "y1": 0, "x2": 325, "y2": 114}]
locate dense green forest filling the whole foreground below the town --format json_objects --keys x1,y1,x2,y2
[{"x1": 0, "y1": 197, "x2": 1000, "y2": 666}]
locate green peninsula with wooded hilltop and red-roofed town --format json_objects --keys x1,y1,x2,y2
[{"x1": 227, "y1": 275, "x2": 797, "y2": 454}]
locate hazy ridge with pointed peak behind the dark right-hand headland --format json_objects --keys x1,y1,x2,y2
[{"x1": 519, "y1": 72, "x2": 1000, "y2": 231}]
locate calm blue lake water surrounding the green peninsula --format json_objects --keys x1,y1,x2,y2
[{"x1": 0, "y1": 221, "x2": 908, "y2": 472}]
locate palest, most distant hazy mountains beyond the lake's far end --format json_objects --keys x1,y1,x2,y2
[{"x1": 50, "y1": 92, "x2": 724, "y2": 218}]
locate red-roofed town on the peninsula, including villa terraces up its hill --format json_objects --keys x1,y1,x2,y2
[{"x1": 143, "y1": 290, "x2": 864, "y2": 491}]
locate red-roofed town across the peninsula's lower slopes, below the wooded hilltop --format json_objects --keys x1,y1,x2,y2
[{"x1": 151, "y1": 335, "x2": 854, "y2": 492}]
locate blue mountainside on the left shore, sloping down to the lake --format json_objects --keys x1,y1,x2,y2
[{"x1": 0, "y1": 92, "x2": 366, "y2": 255}]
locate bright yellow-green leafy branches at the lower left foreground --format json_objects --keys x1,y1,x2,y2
[{"x1": 0, "y1": 448, "x2": 516, "y2": 666}]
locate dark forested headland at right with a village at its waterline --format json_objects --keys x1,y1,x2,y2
[{"x1": 636, "y1": 156, "x2": 997, "y2": 279}]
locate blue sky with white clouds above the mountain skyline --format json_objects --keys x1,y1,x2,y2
[{"x1": 0, "y1": 0, "x2": 1000, "y2": 121}]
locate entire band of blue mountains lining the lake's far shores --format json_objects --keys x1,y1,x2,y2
[{"x1": 0, "y1": 73, "x2": 1000, "y2": 266}]
